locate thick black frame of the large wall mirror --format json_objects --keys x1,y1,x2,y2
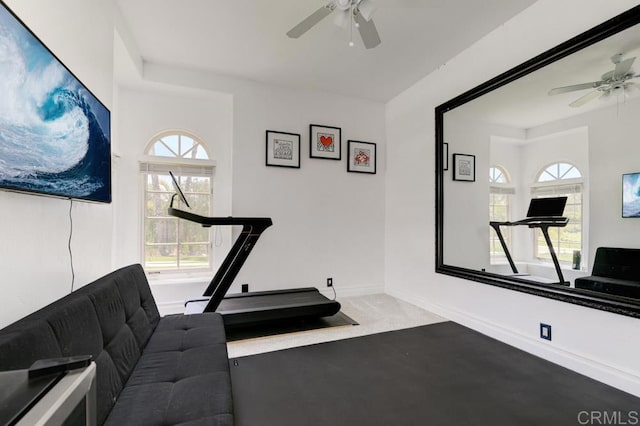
[{"x1": 435, "y1": 6, "x2": 640, "y2": 318}]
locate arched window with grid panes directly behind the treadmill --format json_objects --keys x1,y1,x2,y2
[{"x1": 140, "y1": 131, "x2": 214, "y2": 271}]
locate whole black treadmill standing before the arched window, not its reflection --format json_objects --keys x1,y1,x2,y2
[{"x1": 168, "y1": 172, "x2": 340, "y2": 328}]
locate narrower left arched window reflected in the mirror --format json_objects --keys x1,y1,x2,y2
[{"x1": 489, "y1": 165, "x2": 515, "y2": 265}]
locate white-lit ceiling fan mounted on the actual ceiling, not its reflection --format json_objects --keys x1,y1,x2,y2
[{"x1": 287, "y1": 0, "x2": 381, "y2": 49}]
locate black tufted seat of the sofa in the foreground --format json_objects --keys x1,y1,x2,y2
[{"x1": 106, "y1": 313, "x2": 233, "y2": 426}]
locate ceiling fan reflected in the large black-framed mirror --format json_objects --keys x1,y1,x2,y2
[{"x1": 549, "y1": 54, "x2": 640, "y2": 108}]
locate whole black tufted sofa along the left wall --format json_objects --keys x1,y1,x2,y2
[{"x1": 0, "y1": 265, "x2": 233, "y2": 426}]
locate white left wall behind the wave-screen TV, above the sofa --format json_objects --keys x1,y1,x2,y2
[{"x1": 0, "y1": 0, "x2": 113, "y2": 328}]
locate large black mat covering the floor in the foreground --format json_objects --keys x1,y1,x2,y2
[{"x1": 229, "y1": 322, "x2": 640, "y2": 426}]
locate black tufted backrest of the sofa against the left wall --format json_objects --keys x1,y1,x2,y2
[{"x1": 0, "y1": 265, "x2": 160, "y2": 424}]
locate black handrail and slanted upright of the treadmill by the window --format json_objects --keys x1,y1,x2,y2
[{"x1": 168, "y1": 206, "x2": 273, "y2": 312}]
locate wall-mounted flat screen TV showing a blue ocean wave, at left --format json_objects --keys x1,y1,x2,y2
[{"x1": 0, "y1": 1, "x2": 111, "y2": 203}]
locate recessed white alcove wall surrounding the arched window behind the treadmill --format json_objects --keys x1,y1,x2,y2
[{"x1": 114, "y1": 87, "x2": 233, "y2": 310}]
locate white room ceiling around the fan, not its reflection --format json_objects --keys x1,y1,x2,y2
[{"x1": 117, "y1": 0, "x2": 535, "y2": 102}]
